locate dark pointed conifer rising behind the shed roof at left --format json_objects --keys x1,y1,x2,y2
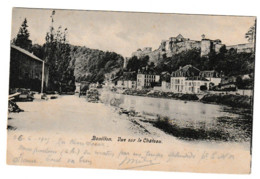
[{"x1": 13, "y1": 18, "x2": 32, "y2": 51}]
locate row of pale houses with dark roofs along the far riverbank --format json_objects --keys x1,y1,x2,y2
[{"x1": 107, "y1": 65, "x2": 221, "y2": 93}]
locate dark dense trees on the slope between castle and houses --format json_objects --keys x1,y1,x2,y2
[{"x1": 155, "y1": 46, "x2": 255, "y2": 76}]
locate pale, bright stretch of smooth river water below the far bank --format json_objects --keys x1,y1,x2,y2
[{"x1": 101, "y1": 91, "x2": 237, "y2": 122}]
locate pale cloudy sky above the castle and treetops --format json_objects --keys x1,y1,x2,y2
[{"x1": 11, "y1": 8, "x2": 255, "y2": 57}]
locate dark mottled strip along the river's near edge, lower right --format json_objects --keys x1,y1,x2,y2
[{"x1": 111, "y1": 105, "x2": 252, "y2": 143}]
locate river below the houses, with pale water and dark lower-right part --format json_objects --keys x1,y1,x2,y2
[{"x1": 101, "y1": 90, "x2": 252, "y2": 141}]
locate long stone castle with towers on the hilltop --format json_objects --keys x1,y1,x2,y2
[{"x1": 128, "y1": 34, "x2": 254, "y2": 66}]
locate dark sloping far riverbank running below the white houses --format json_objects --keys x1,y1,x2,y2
[{"x1": 119, "y1": 89, "x2": 252, "y2": 109}]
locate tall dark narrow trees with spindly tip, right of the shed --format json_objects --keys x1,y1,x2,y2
[{"x1": 43, "y1": 11, "x2": 75, "y2": 93}]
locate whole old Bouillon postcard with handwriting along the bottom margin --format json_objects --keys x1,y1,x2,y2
[{"x1": 7, "y1": 8, "x2": 256, "y2": 174}]
